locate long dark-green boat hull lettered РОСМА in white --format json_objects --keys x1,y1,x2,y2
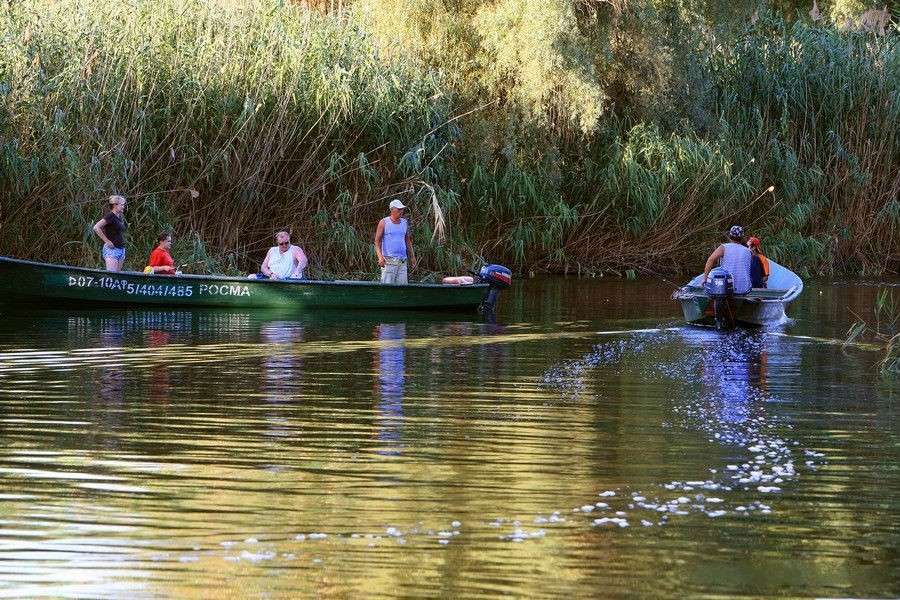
[{"x1": 0, "y1": 256, "x2": 500, "y2": 310}]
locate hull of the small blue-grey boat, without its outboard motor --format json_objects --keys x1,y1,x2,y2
[{"x1": 672, "y1": 259, "x2": 803, "y2": 327}]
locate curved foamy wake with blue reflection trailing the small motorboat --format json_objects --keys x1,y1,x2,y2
[{"x1": 520, "y1": 328, "x2": 824, "y2": 540}]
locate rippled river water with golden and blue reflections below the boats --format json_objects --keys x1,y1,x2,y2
[{"x1": 0, "y1": 279, "x2": 900, "y2": 598}]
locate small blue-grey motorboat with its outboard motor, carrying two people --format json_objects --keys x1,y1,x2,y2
[{"x1": 672, "y1": 259, "x2": 803, "y2": 329}]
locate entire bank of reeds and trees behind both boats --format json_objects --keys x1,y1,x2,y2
[{"x1": 0, "y1": 0, "x2": 900, "y2": 275}]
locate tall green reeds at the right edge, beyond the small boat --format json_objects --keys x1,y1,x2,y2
[{"x1": 716, "y1": 18, "x2": 900, "y2": 274}]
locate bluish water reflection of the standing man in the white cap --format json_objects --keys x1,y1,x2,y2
[{"x1": 375, "y1": 323, "x2": 406, "y2": 455}]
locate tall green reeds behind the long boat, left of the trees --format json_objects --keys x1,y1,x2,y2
[{"x1": 0, "y1": 0, "x2": 448, "y2": 270}]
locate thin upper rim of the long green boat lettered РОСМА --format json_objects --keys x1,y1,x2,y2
[{"x1": 0, "y1": 256, "x2": 490, "y2": 290}]
